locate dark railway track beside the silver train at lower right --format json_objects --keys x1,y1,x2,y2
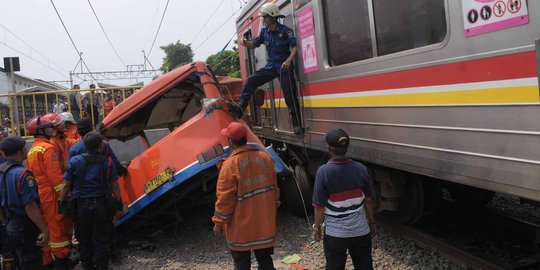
[{"x1": 378, "y1": 206, "x2": 540, "y2": 270}]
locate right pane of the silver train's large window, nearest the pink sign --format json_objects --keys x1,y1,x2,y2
[{"x1": 373, "y1": 0, "x2": 446, "y2": 55}]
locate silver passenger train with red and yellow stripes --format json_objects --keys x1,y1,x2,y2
[{"x1": 236, "y1": 0, "x2": 540, "y2": 223}]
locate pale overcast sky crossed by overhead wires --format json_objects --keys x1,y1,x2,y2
[{"x1": 0, "y1": 0, "x2": 245, "y2": 85}]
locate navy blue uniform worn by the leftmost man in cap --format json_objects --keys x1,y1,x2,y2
[{"x1": 0, "y1": 160, "x2": 42, "y2": 269}]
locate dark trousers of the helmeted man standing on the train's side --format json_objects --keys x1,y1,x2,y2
[{"x1": 240, "y1": 65, "x2": 301, "y2": 127}]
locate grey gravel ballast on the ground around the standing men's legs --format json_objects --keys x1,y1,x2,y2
[{"x1": 106, "y1": 211, "x2": 462, "y2": 270}]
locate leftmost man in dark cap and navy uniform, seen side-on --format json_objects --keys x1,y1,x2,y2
[{"x1": 0, "y1": 136, "x2": 49, "y2": 270}]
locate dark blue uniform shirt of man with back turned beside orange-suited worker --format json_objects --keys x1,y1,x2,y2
[{"x1": 64, "y1": 152, "x2": 118, "y2": 199}]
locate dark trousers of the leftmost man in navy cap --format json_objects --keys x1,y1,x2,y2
[{"x1": 4, "y1": 215, "x2": 42, "y2": 270}]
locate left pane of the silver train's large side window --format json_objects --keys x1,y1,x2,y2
[{"x1": 323, "y1": 0, "x2": 374, "y2": 66}]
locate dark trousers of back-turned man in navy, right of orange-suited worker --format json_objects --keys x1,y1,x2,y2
[{"x1": 75, "y1": 199, "x2": 112, "y2": 269}]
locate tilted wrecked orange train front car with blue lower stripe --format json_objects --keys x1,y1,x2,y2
[{"x1": 100, "y1": 62, "x2": 286, "y2": 229}]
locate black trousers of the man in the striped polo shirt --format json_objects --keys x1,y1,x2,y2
[{"x1": 323, "y1": 234, "x2": 373, "y2": 270}]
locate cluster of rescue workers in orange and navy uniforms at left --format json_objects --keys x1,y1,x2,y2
[{"x1": 0, "y1": 112, "x2": 125, "y2": 269}]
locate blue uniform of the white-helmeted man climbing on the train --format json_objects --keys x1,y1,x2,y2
[{"x1": 240, "y1": 23, "x2": 301, "y2": 130}]
